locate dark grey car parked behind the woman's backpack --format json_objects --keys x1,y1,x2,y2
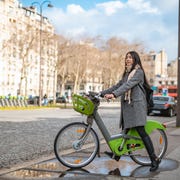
[{"x1": 148, "y1": 95, "x2": 177, "y2": 117}]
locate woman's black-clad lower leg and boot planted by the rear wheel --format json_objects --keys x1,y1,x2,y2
[{"x1": 142, "y1": 136, "x2": 161, "y2": 171}]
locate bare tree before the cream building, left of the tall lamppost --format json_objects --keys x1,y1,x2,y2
[{"x1": 3, "y1": 25, "x2": 37, "y2": 95}]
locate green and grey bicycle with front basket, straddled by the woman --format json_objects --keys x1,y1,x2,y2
[{"x1": 54, "y1": 92, "x2": 168, "y2": 168}]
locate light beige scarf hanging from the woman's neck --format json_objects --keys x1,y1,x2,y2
[{"x1": 124, "y1": 64, "x2": 140, "y2": 104}]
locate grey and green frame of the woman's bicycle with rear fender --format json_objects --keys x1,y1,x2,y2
[{"x1": 89, "y1": 108, "x2": 165, "y2": 156}]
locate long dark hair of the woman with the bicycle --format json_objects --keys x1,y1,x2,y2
[{"x1": 123, "y1": 51, "x2": 150, "y2": 87}]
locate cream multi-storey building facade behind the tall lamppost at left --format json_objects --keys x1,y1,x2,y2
[{"x1": 0, "y1": 0, "x2": 57, "y2": 96}]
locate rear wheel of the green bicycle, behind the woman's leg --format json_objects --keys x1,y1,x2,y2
[{"x1": 129, "y1": 129, "x2": 168, "y2": 165}]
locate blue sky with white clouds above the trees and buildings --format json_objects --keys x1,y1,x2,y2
[{"x1": 19, "y1": 0, "x2": 178, "y2": 62}]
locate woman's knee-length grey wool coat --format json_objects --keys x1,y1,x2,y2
[{"x1": 101, "y1": 69, "x2": 147, "y2": 129}]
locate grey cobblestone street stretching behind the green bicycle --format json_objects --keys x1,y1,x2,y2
[{"x1": 0, "y1": 106, "x2": 175, "y2": 175}]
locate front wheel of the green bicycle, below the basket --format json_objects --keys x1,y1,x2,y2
[{"x1": 54, "y1": 122, "x2": 99, "y2": 168}]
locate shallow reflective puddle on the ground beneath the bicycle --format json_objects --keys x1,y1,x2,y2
[{"x1": 0, "y1": 156, "x2": 178, "y2": 180}]
